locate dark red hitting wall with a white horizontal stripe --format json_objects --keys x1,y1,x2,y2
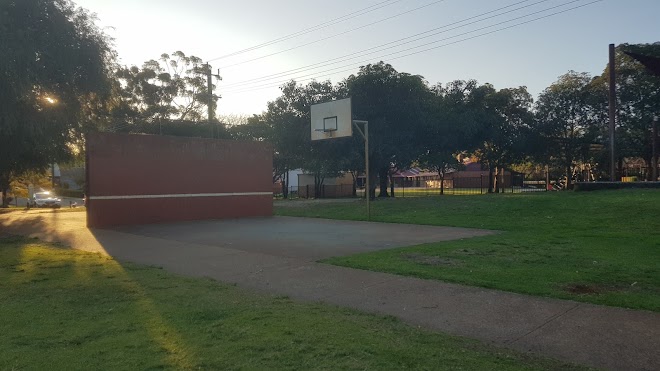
[{"x1": 86, "y1": 133, "x2": 273, "y2": 227}]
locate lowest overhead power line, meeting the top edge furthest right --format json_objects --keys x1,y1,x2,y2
[{"x1": 227, "y1": 0, "x2": 604, "y2": 95}]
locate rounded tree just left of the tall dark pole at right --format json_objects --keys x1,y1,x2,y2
[{"x1": 533, "y1": 71, "x2": 602, "y2": 188}]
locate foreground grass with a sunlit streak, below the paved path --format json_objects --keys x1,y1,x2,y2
[{"x1": 0, "y1": 236, "x2": 584, "y2": 370}]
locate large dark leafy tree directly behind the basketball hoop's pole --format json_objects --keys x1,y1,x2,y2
[{"x1": 340, "y1": 62, "x2": 432, "y2": 197}]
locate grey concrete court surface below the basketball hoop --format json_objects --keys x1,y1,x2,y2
[{"x1": 115, "y1": 216, "x2": 496, "y2": 261}]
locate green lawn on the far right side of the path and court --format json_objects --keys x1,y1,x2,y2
[{"x1": 276, "y1": 190, "x2": 660, "y2": 311}]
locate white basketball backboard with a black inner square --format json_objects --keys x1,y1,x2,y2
[{"x1": 311, "y1": 98, "x2": 353, "y2": 140}]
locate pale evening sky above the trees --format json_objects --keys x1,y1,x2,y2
[{"x1": 73, "y1": 0, "x2": 660, "y2": 116}]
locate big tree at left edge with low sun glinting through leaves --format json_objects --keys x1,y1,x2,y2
[{"x1": 0, "y1": 0, "x2": 115, "y2": 205}]
